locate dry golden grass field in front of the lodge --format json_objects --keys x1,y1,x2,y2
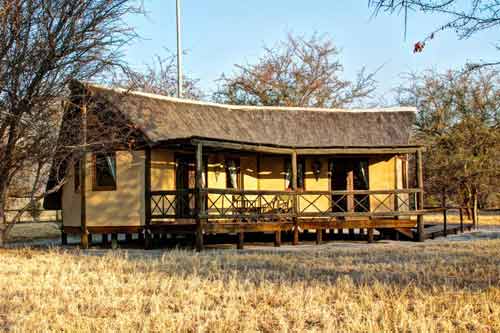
[{"x1": 0, "y1": 239, "x2": 500, "y2": 332}]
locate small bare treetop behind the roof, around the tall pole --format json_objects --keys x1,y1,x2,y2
[{"x1": 112, "y1": 51, "x2": 203, "y2": 99}]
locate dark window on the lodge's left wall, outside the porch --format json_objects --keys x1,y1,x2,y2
[{"x1": 93, "y1": 152, "x2": 116, "y2": 191}]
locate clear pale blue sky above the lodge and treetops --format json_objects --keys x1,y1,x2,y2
[{"x1": 125, "y1": 0, "x2": 498, "y2": 102}]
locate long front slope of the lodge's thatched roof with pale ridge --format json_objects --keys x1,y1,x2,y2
[{"x1": 87, "y1": 85, "x2": 415, "y2": 148}]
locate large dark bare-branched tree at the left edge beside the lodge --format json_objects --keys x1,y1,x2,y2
[{"x1": 0, "y1": 0, "x2": 138, "y2": 245}]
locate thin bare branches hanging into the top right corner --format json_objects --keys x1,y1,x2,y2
[{"x1": 368, "y1": 0, "x2": 500, "y2": 69}]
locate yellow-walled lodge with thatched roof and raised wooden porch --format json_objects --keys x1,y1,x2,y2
[{"x1": 44, "y1": 84, "x2": 423, "y2": 250}]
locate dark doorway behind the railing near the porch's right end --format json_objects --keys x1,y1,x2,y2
[{"x1": 330, "y1": 158, "x2": 370, "y2": 212}]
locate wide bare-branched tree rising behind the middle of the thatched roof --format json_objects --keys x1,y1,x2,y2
[{"x1": 214, "y1": 34, "x2": 375, "y2": 108}]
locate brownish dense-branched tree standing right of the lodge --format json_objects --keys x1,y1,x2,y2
[{"x1": 399, "y1": 68, "x2": 500, "y2": 213}]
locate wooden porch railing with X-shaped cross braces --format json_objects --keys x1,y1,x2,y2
[{"x1": 150, "y1": 188, "x2": 420, "y2": 221}]
